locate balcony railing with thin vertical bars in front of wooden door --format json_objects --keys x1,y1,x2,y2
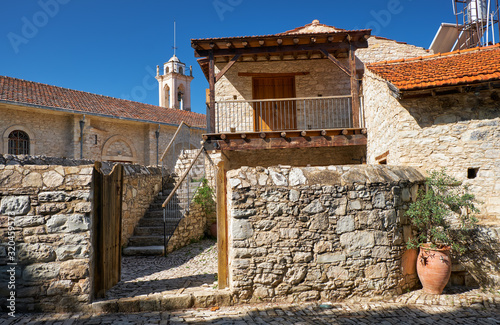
[{"x1": 215, "y1": 96, "x2": 364, "y2": 133}]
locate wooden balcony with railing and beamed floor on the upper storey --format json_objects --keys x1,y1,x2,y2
[{"x1": 203, "y1": 96, "x2": 366, "y2": 150}]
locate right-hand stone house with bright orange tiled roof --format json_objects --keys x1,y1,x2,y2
[{"x1": 363, "y1": 44, "x2": 500, "y2": 223}]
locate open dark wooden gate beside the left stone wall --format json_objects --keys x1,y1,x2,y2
[{"x1": 92, "y1": 162, "x2": 123, "y2": 298}]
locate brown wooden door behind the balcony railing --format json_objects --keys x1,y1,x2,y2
[{"x1": 253, "y1": 76, "x2": 297, "y2": 131}]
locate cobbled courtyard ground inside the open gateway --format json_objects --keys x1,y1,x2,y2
[{"x1": 106, "y1": 239, "x2": 217, "y2": 299}]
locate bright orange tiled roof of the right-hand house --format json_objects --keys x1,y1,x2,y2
[{"x1": 367, "y1": 44, "x2": 500, "y2": 90}]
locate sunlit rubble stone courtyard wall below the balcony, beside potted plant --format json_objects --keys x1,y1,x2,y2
[{"x1": 227, "y1": 166, "x2": 424, "y2": 301}]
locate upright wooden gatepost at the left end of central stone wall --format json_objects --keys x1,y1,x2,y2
[{"x1": 217, "y1": 161, "x2": 229, "y2": 289}]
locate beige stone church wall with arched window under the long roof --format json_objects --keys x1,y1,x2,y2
[{"x1": 0, "y1": 103, "x2": 204, "y2": 165}]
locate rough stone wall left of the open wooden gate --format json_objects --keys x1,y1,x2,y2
[{"x1": 0, "y1": 155, "x2": 93, "y2": 313}]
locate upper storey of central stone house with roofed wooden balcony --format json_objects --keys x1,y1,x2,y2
[{"x1": 192, "y1": 20, "x2": 429, "y2": 167}]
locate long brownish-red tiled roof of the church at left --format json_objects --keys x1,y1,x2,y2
[{"x1": 0, "y1": 76, "x2": 206, "y2": 127}]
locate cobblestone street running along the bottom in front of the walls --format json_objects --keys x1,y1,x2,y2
[{"x1": 0, "y1": 303, "x2": 500, "y2": 325}]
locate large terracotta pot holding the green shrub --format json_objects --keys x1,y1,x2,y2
[{"x1": 417, "y1": 244, "x2": 451, "y2": 295}]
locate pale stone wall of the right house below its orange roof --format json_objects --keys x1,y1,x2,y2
[{"x1": 364, "y1": 71, "x2": 500, "y2": 221}]
